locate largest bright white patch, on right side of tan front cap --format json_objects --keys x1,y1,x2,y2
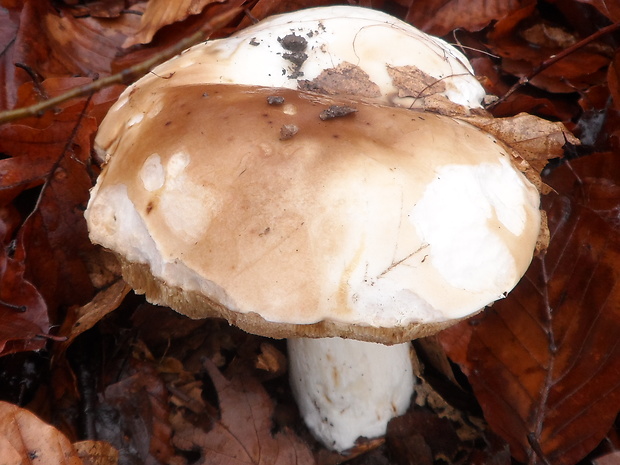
[{"x1": 409, "y1": 163, "x2": 528, "y2": 292}]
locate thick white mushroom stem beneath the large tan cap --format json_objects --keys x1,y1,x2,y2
[{"x1": 288, "y1": 338, "x2": 415, "y2": 452}]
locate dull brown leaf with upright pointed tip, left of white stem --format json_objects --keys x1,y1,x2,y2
[{"x1": 175, "y1": 361, "x2": 314, "y2": 465}]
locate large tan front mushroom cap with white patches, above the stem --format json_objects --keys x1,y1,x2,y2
[{"x1": 86, "y1": 85, "x2": 540, "y2": 343}]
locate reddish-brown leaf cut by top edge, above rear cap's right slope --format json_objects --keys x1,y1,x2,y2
[{"x1": 398, "y1": 0, "x2": 533, "y2": 36}]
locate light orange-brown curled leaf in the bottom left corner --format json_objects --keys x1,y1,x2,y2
[{"x1": 0, "y1": 402, "x2": 83, "y2": 465}]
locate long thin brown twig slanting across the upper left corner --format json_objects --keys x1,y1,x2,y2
[{"x1": 0, "y1": 8, "x2": 242, "y2": 124}]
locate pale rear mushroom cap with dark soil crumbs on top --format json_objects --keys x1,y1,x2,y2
[{"x1": 115, "y1": 6, "x2": 485, "y2": 115}]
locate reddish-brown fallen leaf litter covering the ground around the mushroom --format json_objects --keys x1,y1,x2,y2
[{"x1": 0, "y1": 0, "x2": 620, "y2": 465}]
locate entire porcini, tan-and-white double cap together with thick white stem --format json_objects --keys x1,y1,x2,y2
[{"x1": 86, "y1": 7, "x2": 540, "y2": 451}]
